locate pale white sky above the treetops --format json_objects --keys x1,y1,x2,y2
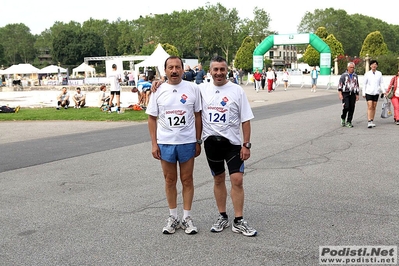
[{"x1": 0, "y1": 0, "x2": 399, "y2": 34}]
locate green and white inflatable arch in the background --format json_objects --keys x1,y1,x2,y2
[{"x1": 253, "y1": 33, "x2": 331, "y2": 75}]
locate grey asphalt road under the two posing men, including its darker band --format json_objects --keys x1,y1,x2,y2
[{"x1": 0, "y1": 90, "x2": 399, "y2": 266}]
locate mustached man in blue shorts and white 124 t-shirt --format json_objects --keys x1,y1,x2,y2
[{"x1": 146, "y1": 56, "x2": 202, "y2": 234}]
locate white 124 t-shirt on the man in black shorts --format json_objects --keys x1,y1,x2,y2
[{"x1": 200, "y1": 81, "x2": 254, "y2": 145}]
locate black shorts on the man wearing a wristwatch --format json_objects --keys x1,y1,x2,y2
[{"x1": 204, "y1": 136, "x2": 244, "y2": 176}]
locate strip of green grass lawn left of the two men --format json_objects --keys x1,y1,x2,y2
[{"x1": 0, "y1": 107, "x2": 148, "y2": 122}]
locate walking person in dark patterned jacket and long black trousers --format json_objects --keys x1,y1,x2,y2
[{"x1": 338, "y1": 62, "x2": 359, "y2": 128}]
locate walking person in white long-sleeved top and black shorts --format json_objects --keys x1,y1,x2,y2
[{"x1": 362, "y1": 60, "x2": 385, "y2": 128}]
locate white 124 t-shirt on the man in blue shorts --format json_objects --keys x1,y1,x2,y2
[{"x1": 146, "y1": 80, "x2": 201, "y2": 145}]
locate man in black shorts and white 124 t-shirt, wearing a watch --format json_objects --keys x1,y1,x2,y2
[{"x1": 200, "y1": 56, "x2": 259, "y2": 236}]
